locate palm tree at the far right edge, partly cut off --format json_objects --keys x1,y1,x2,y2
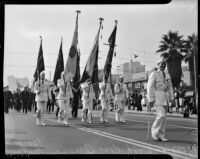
[{"x1": 184, "y1": 34, "x2": 198, "y2": 88}]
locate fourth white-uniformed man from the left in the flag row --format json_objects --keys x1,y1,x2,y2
[{"x1": 99, "y1": 78, "x2": 113, "y2": 122}]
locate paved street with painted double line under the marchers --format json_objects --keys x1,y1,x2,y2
[{"x1": 5, "y1": 110, "x2": 198, "y2": 159}]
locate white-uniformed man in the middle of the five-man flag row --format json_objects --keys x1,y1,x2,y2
[{"x1": 81, "y1": 79, "x2": 96, "y2": 124}]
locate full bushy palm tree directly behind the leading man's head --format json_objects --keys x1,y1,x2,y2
[{"x1": 156, "y1": 30, "x2": 185, "y2": 87}]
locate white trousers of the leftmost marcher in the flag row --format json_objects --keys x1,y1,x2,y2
[{"x1": 37, "y1": 101, "x2": 47, "y2": 123}]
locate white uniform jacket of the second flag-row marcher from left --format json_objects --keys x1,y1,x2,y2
[{"x1": 57, "y1": 79, "x2": 73, "y2": 100}]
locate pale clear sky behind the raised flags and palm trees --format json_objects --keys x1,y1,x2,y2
[{"x1": 3, "y1": 0, "x2": 197, "y2": 85}]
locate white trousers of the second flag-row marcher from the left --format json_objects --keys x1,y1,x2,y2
[{"x1": 58, "y1": 99, "x2": 70, "y2": 122}]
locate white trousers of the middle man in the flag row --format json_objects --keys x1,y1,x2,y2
[{"x1": 81, "y1": 100, "x2": 93, "y2": 121}]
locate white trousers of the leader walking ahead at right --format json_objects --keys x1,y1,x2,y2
[{"x1": 151, "y1": 106, "x2": 167, "y2": 138}]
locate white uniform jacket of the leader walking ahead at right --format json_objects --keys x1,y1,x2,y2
[{"x1": 147, "y1": 70, "x2": 174, "y2": 106}]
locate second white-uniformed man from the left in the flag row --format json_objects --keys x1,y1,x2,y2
[{"x1": 57, "y1": 72, "x2": 73, "y2": 125}]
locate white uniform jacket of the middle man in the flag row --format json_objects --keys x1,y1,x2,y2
[{"x1": 81, "y1": 82, "x2": 96, "y2": 100}]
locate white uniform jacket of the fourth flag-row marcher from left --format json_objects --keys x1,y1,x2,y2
[{"x1": 99, "y1": 82, "x2": 113, "y2": 101}]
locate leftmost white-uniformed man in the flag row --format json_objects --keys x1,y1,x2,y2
[{"x1": 34, "y1": 72, "x2": 52, "y2": 126}]
